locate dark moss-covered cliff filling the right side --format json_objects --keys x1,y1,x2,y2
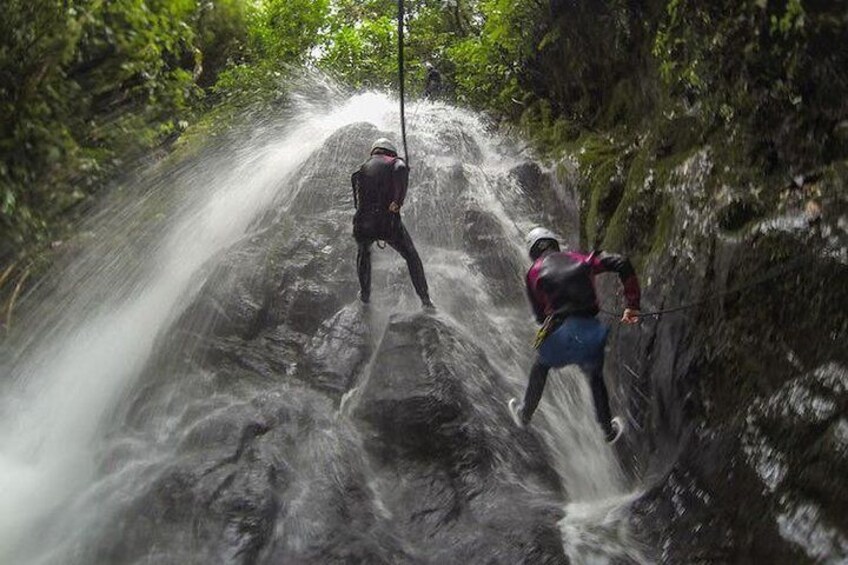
[{"x1": 500, "y1": 1, "x2": 848, "y2": 563}]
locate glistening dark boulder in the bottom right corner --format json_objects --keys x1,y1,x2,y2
[{"x1": 743, "y1": 363, "x2": 848, "y2": 561}]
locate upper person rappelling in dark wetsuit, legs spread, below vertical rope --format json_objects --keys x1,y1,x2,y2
[{"x1": 351, "y1": 138, "x2": 435, "y2": 309}]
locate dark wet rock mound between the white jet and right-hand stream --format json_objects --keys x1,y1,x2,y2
[{"x1": 77, "y1": 121, "x2": 567, "y2": 564}]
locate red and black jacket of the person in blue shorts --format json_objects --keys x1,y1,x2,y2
[{"x1": 527, "y1": 251, "x2": 641, "y2": 323}]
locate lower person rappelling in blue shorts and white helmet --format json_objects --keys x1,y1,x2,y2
[{"x1": 508, "y1": 227, "x2": 641, "y2": 443}]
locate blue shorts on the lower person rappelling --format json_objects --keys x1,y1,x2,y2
[{"x1": 539, "y1": 316, "x2": 609, "y2": 367}]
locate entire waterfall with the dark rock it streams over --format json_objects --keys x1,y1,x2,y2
[{"x1": 0, "y1": 86, "x2": 645, "y2": 563}]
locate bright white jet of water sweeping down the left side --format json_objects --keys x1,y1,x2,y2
[{"x1": 0, "y1": 90, "x2": 393, "y2": 563}]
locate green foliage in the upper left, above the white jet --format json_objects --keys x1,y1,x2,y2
[{"x1": 0, "y1": 0, "x2": 329, "y2": 263}]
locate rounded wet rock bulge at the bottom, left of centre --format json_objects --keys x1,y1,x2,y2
[{"x1": 90, "y1": 386, "x2": 412, "y2": 563}]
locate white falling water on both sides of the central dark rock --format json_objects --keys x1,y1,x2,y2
[{"x1": 0, "y1": 86, "x2": 639, "y2": 563}]
